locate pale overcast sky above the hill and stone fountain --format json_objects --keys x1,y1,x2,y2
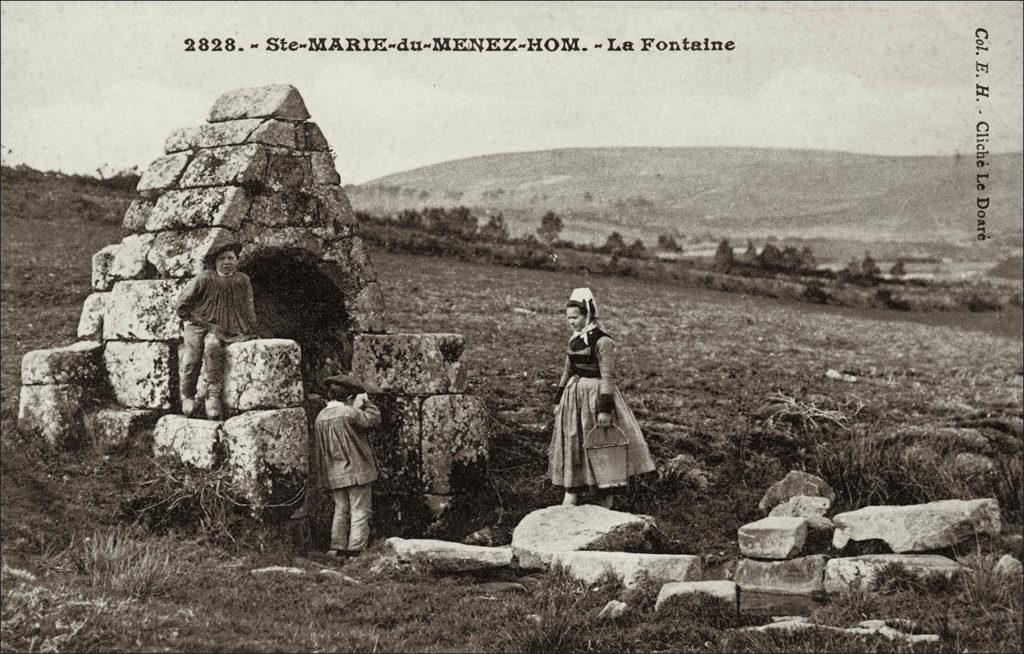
[{"x1": 0, "y1": 2, "x2": 1024, "y2": 183}]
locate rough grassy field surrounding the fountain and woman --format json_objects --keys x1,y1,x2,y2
[{"x1": 0, "y1": 203, "x2": 1024, "y2": 651}]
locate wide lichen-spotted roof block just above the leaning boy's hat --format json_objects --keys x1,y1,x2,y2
[{"x1": 145, "y1": 186, "x2": 252, "y2": 231}]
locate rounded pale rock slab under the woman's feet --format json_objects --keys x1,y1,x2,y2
[{"x1": 512, "y1": 505, "x2": 657, "y2": 569}]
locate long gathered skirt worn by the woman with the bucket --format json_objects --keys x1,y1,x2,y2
[{"x1": 548, "y1": 377, "x2": 654, "y2": 489}]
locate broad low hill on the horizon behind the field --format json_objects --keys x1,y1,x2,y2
[{"x1": 347, "y1": 147, "x2": 1024, "y2": 243}]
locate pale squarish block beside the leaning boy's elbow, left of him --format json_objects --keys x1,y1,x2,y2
[{"x1": 103, "y1": 279, "x2": 184, "y2": 341}]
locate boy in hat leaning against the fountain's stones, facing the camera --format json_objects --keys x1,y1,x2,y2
[{"x1": 176, "y1": 235, "x2": 256, "y2": 420}]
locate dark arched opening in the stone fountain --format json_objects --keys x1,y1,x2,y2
[{"x1": 239, "y1": 248, "x2": 352, "y2": 393}]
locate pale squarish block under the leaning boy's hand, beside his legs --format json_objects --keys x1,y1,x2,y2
[{"x1": 223, "y1": 339, "x2": 303, "y2": 411}]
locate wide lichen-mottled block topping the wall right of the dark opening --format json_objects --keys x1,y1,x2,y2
[{"x1": 352, "y1": 334, "x2": 466, "y2": 395}]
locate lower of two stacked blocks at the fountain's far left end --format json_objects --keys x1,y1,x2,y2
[{"x1": 17, "y1": 384, "x2": 89, "y2": 449}]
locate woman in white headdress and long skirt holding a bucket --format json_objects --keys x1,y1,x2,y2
[{"x1": 548, "y1": 289, "x2": 654, "y2": 506}]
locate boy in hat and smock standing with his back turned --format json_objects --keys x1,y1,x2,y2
[{"x1": 314, "y1": 375, "x2": 381, "y2": 557}]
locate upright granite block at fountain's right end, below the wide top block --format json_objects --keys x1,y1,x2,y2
[{"x1": 421, "y1": 395, "x2": 490, "y2": 494}]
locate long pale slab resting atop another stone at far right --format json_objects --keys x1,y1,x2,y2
[{"x1": 833, "y1": 498, "x2": 1000, "y2": 553}]
